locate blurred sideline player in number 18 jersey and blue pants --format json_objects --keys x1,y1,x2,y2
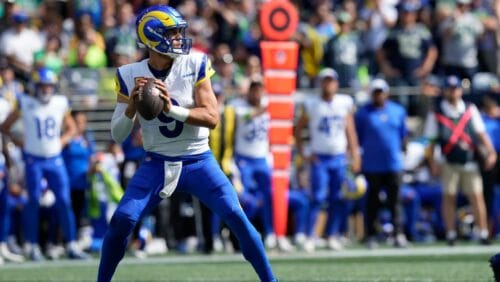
[{"x1": 0, "y1": 68, "x2": 88, "y2": 261}]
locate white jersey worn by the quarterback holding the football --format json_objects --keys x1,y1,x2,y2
[{"x1": 116, "y1": 52, "x2": 215, "y2": 156}]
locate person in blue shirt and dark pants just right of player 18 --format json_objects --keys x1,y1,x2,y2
[{"x1": 62, "y1": 111, "x2": 95, "y2": 234}]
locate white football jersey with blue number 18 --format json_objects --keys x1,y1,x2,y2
[{"x1": 19, "y1": 95, "x2": 70, "y2": 158}]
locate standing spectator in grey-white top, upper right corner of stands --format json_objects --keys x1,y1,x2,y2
[{"x1": 439, "y1": 0, "x2": 484, "y2": 80}]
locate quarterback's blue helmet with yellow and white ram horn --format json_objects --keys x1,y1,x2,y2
[{"x1": 136, "y1": 5, "x2": 192, "y2": 57}]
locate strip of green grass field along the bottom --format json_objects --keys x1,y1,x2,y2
[{"x1": 0, "y1": 245, "x2": 500, "y2": 282}]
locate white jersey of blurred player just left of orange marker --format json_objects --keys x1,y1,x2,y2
[{"x1": 234, "y1": 101, "x2": 270, "y2": 158}]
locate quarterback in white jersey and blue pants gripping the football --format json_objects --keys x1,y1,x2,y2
[{"x1": 97, "y1": 5, "x2": 276, "y2": 282}]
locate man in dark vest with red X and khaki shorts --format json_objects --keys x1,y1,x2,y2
[{"x1": 424, "y1": 76, "x2": 497, "y2": 246}]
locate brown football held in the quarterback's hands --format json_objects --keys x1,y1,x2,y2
[{"x1": 134, "y1": 78, "x2": 165, "y2": 120}]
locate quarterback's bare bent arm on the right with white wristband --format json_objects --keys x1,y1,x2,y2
[{"x1": 155, "y1": 75, "x2": 219, "y2": 129}]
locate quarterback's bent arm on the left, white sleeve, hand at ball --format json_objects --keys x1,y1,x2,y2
[{"x1": 111, "y1": 78, "x2": 146, "y2": 144}]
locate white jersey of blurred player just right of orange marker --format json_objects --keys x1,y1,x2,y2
[{"x1": 304, "y1": 94, "x2": 354, "y2": 155}]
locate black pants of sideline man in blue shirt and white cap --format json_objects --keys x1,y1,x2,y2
[{"x1": 364, "y1": 172, "x2": 401, "y2": 237}]
